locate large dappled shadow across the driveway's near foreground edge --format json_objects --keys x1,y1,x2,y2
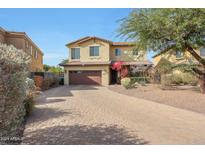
[{"x1": 23, "y1": 125, "x2": 149, "y2": 145}]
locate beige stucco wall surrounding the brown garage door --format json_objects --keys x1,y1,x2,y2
[{"x1": 64, "y1": 65, "x2": 110, "y2": 86}]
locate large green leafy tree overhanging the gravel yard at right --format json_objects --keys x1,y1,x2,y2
[{"x1": 118, "y1": 9, "x2": 205, "y2": 93}]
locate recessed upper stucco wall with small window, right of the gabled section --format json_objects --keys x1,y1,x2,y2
[{"x1": 110, "y1": 46, "x2": 146, "y2": 61}]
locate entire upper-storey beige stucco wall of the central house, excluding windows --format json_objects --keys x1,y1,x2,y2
[{"x1": 69, "y1": 39, "x2": 147, "y2": 62}]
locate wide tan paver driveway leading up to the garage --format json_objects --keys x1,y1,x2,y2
[{"x1": 22, "y1": 86, "x2": 205, "y2": 144}]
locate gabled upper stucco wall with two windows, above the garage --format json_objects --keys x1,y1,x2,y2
[{"x1": 69, "y1": 40, "x2": 110, "y2": 62}]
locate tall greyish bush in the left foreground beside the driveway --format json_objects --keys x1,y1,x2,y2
[{"x1": 0, "y1": 44, "x2": 30, "y2": 142}]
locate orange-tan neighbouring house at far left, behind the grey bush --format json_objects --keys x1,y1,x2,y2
[{"x1": 0, "y1": 27, "x2": 43, "y2": 72}]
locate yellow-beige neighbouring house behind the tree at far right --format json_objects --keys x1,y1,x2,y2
[{"x1": 153, "y1": 48, "x2": 205, "y2": 66}]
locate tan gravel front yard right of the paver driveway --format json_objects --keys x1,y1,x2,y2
[{"x1": 109, "y1": 84, "x2": 205, "y2": 114}]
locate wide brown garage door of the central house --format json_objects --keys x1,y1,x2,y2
[{"x1": 69, "y1": 71, "x2": 101, "y2": 85}]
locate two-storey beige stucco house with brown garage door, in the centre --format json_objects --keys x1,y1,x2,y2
[{"x1": 61, "y1": 36, "x2": 152, "y2": 86}]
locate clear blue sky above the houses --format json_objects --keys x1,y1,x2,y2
[{"x1": 0, "y1": 9, "x2": 152, "y2": 66}]
